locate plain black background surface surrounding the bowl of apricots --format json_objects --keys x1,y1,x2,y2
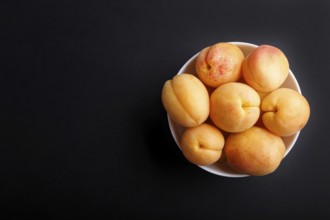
[{"x1": 0, "y1": 0, "x2": 330, "y2": 219}]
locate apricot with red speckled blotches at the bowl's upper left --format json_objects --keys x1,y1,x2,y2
[{"x1": 195, "y1": 43, "x2": 244, "y2": 88}]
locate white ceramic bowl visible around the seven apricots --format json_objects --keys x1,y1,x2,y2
[{"x1": 167, "y1": 42, "x2": 301, "y2": 177}]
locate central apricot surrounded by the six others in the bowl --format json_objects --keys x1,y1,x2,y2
[{"x1": 210, "y1": 82, "x2": 260, "y2": 132}]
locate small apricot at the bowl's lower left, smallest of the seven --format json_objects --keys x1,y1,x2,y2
[{"x1": 180, "y1": 123, "x2": 225, "y2": 166}]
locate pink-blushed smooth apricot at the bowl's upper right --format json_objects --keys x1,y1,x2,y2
[{"x1": 242, "y1": 45, "x2": 289, "y2": 92}]
